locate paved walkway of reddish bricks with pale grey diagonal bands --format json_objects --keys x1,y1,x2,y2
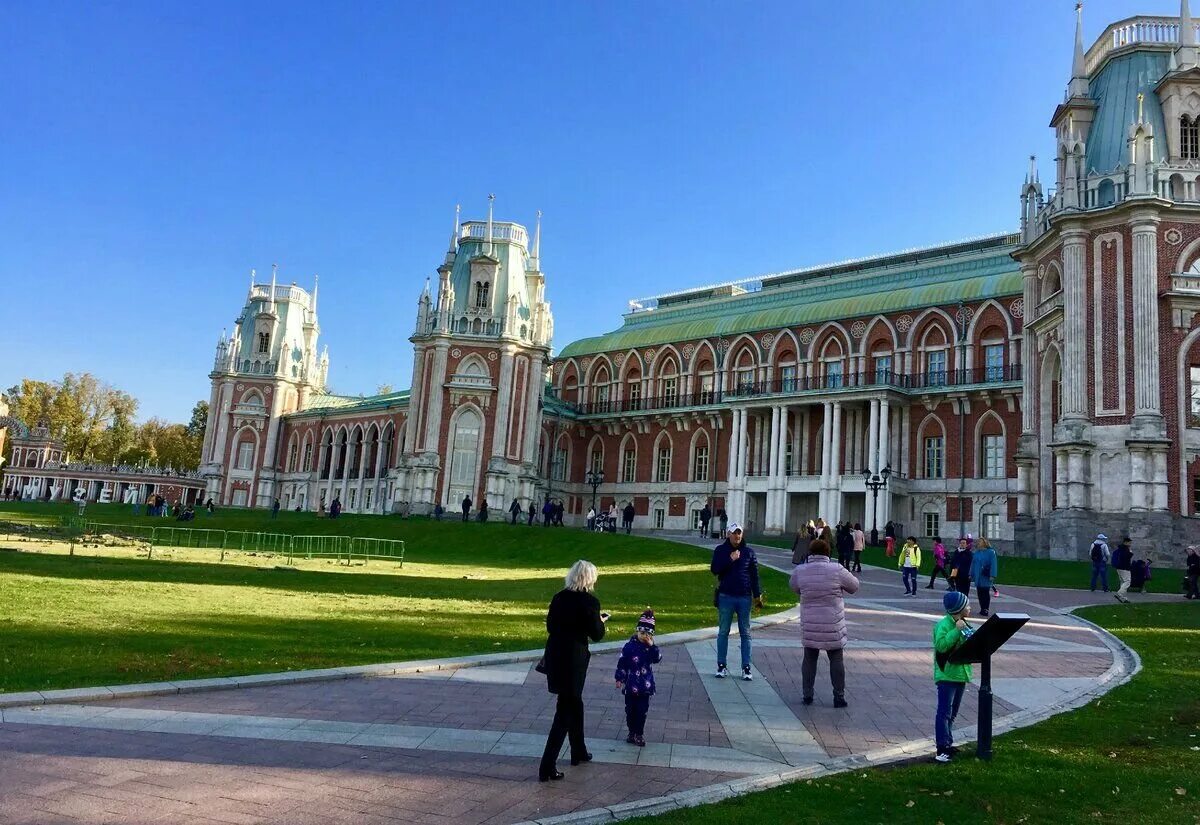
[{"x1": 0, "y1": 542, "x2": 1136, "y2": 825}]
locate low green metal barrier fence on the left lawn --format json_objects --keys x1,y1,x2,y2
[{"x1": 64, "y1": 516, "x2": 404, "y2": 567}]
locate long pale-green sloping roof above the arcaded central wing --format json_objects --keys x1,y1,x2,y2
[{"x1": 557, "y1": 236, "x2": 1021, "y2": 359}]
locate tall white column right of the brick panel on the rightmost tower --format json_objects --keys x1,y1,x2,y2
[{"x1": 1133, "y1": 215, "x2": 1162, "y2": 417}]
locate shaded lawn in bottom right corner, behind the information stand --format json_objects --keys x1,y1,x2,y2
[{"x1": 630, "y1": 603, "x2": 1200, "y2": 825}]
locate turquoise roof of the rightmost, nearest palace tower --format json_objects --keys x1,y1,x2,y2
[{"x1": 1085, "y1": 49, "x2": 1170, "y2": 174}]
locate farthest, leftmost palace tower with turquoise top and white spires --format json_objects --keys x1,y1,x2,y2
[{"x1": 200, "y1": 266, "x2": 329, "y2": 507}]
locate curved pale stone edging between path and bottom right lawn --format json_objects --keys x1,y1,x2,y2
[{"x1": 508, "y1": 601, "x2": 1141, "y2": 825}]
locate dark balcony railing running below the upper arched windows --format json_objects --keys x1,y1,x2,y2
[{"x1": 574, "y1": 363, "x2": 1021, "y2": 415}]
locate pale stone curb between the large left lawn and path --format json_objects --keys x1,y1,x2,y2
[{"x1": 0, "y1": 607, "x2": 800, "y2": 707}]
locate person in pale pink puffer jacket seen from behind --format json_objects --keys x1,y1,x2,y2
[{"x1": 790, "y1": 538, "x2": 858, "y2": 707}]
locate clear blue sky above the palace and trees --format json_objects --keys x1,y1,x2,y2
[{"x1": 0, "y1": 0, "x2": 1178, "y2": 420}]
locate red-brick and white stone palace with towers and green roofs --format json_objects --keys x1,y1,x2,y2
[{"x1": 145, "y1": 0, "x2": 1200, "y2": 558}]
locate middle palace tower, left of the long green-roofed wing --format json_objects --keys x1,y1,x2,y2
[{"x1": 404, "y1": 195, "x2": 553, "y2": 510}]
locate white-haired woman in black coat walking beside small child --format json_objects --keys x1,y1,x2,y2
[{"x1": 538, "y1": 560, "x2": 608, "y2": 782}]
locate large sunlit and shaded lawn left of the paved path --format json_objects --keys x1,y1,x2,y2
[{"x1": 0, "y1": 505, "x2": 787, "y2": 691}]
